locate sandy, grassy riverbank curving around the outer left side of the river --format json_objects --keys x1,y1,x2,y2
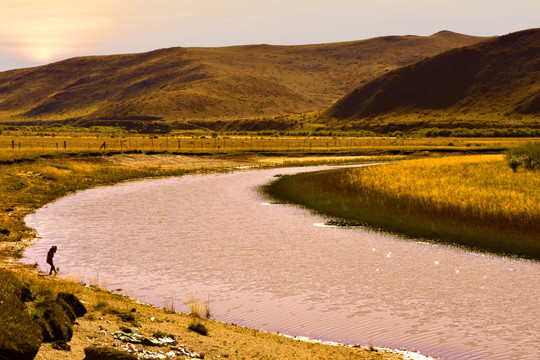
[{"x1": 0, "y1": 154, "x2": 422, "y2": 359}]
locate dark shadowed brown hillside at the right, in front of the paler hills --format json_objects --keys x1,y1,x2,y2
[{"x1": 326, "y1": 29, "x2": 540, "y2": 128}]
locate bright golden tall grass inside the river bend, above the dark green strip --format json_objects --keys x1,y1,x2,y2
[{"x1": 340, "y1": 155, "x2": 540, "y2": 233}]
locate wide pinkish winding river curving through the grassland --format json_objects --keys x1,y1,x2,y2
[{"x1": 23, "y1": 167, "x2": 540, "y2": 360}]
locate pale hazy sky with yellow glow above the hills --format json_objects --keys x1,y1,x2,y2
[{"x1": 0, "y1": 0, "x2": 540, "y2": 71}]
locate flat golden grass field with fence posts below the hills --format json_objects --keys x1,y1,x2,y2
[{"x1": 0, "y1": 130, "x2": 530, "y2": 161}]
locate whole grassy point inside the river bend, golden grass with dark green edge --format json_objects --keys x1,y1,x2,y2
[{"x1": 268, "y1": 155, "x2": 540, "y2": 260}]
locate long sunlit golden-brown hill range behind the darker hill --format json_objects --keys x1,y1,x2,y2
[{"x1": 0, "y1": 31, "x2": 485, "y2": 127}]
